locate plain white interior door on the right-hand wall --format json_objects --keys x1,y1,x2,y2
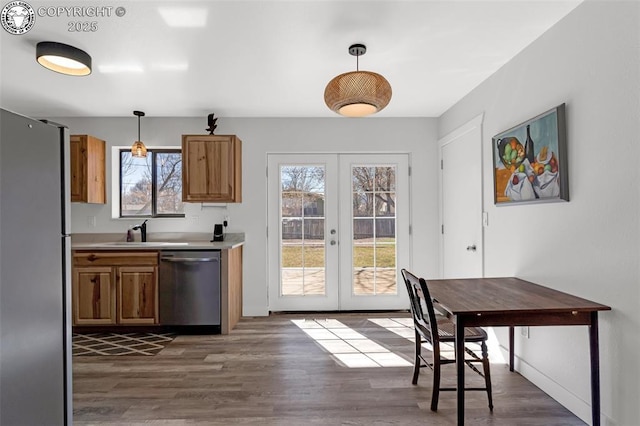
[{"x1": 440, "y1": 116, "x2": 483, "y2": 278}]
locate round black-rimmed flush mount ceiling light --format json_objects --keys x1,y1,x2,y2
[{"x1": 36, "y1": 41, "x2": 91, "y2": 76}]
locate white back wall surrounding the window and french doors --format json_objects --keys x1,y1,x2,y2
[{"x1": 54, "y1": 116, "x2": 440, "y2": 316}]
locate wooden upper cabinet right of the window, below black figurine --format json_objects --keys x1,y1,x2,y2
[{"x1": 182, "y1": 135, "x2": 242, "y2": 203}]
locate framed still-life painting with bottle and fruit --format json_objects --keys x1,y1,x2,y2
[{"x1": 491, "y1": 104, "x2": 569, "y2": 205}]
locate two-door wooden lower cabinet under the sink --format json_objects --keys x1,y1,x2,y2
[{"x1": 72, "y1": 251, "x2": 158, "y2": 326}]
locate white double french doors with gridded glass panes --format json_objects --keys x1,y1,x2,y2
[{"x1": 268, "y1": 154, "x2": 409, "y2": 311}]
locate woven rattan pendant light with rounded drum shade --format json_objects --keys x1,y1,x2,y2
[{"x1": 324, "y1": 44, "x2": 391, "y2": 117}]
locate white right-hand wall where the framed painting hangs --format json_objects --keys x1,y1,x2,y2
[{"x1": 439, "y1": 1, "x2": 640, "y2": 426}]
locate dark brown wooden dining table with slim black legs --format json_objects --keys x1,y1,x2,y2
[{"x1": 427, "y1": 277, "x2": 611, "y2": 426}]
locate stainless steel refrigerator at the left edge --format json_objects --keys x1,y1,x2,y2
[{"x1": 0, "y1": 109, "x2": 73, "y2": 426}]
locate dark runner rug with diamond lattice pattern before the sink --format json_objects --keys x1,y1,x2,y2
[{"x1": 73, "y1": 333, "x2": 176, "y2": 356}]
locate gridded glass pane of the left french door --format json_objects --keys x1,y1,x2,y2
[{"x1": 280, "y1": 165, "x2": 326, "y2": 296}]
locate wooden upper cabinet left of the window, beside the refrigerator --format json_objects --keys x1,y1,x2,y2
[{"x1": 70, "y1": 135, "x2": 107, "y2": 204}]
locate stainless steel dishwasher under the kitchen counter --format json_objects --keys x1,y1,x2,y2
[{"x1": 158, "y1": 250, "x2": 220, "y2": 325}]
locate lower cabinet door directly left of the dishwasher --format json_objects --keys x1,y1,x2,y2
[{"x1": 118, "y1": 266, "x2": 158, "y2": 324}]
